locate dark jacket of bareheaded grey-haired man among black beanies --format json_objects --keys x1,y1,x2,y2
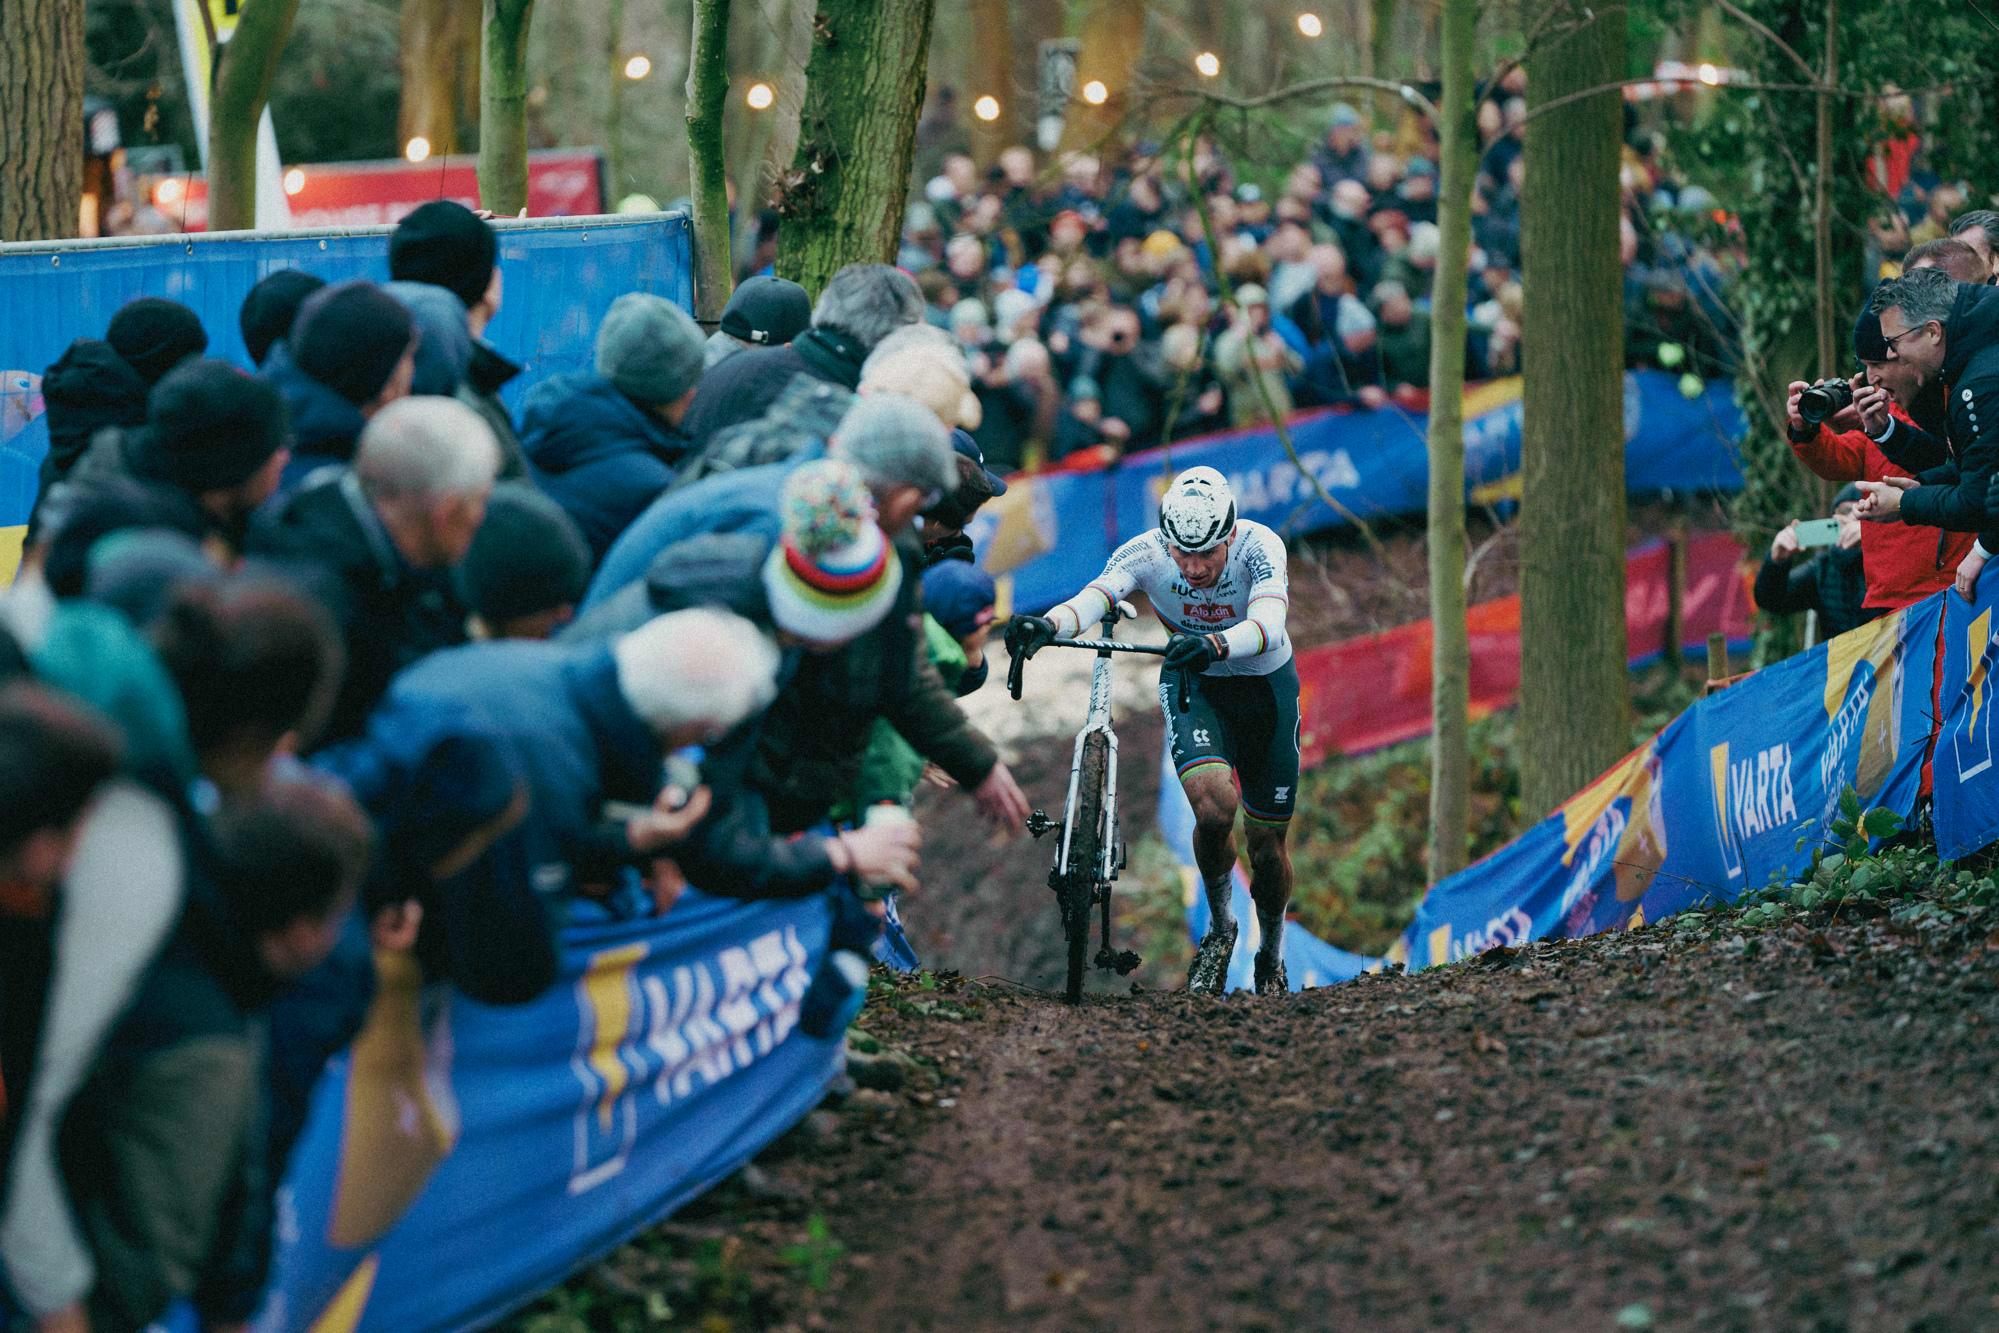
[{"x1": 250, "y1": 468, "x2": 466, "y2": 741}]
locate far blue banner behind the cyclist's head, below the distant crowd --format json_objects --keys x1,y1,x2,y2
[{"x1": 972, "y1": 372, "x2": 1743, "y2": 612}]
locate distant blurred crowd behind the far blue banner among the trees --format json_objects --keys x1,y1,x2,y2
[{"x1": 875, "y1": 72, "x2": 1739, "y2": 468}]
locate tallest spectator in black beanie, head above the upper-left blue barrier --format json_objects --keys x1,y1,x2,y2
[{"x1": 388, "y1": 200, "x2": 528, "y2": 473}]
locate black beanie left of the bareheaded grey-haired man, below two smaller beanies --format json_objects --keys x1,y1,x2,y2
[{"x1": 132, "y1": 362, "x2": 286, "y2": 496}]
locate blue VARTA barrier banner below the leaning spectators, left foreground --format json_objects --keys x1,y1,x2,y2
[{"x1": 256, "y1": 891, "x2": 842, "y2": 1333}]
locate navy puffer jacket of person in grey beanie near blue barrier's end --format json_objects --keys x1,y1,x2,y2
[{"x1": 520, "y1": 374, "x2": 688, "y2": 560}]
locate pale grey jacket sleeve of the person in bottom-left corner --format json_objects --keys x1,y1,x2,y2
[{"x1": 0, "y1": 781, "x2": 186, "y2": 1315}]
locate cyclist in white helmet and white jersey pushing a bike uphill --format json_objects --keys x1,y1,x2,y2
[{"x1": 1005, "y1": 468, "x2": 1299, "y2": 995}]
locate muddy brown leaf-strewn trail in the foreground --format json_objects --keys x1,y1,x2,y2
[{"x1": 530, "y1": 887, "x2": 1999, "y2": 1333}]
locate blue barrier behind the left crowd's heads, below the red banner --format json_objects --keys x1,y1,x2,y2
[{"x1": 0, "y1": 214, "x2": 694, "y2": 528}]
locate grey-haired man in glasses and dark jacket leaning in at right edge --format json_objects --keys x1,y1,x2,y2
[{"x1": 1861, "y1": 268, "x2": 1999, "y2": 600}]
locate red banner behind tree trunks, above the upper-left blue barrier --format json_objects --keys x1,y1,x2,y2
[{"x1": 152, "y1": 148, "x2": 604, "y2": 232}]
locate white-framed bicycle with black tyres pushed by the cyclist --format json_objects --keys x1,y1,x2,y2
[{"x1": 1005, "y1": 602, "x2": 1189, "y2": 1005}]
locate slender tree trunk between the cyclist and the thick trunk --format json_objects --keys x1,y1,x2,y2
[{"x1": 1429, "y1": 0, "x2": 1479, "y2": 883}]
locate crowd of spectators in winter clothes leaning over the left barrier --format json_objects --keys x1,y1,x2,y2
[{"x1": 0, "y1": 202, "x2": 1027, "y2": 1329}]
